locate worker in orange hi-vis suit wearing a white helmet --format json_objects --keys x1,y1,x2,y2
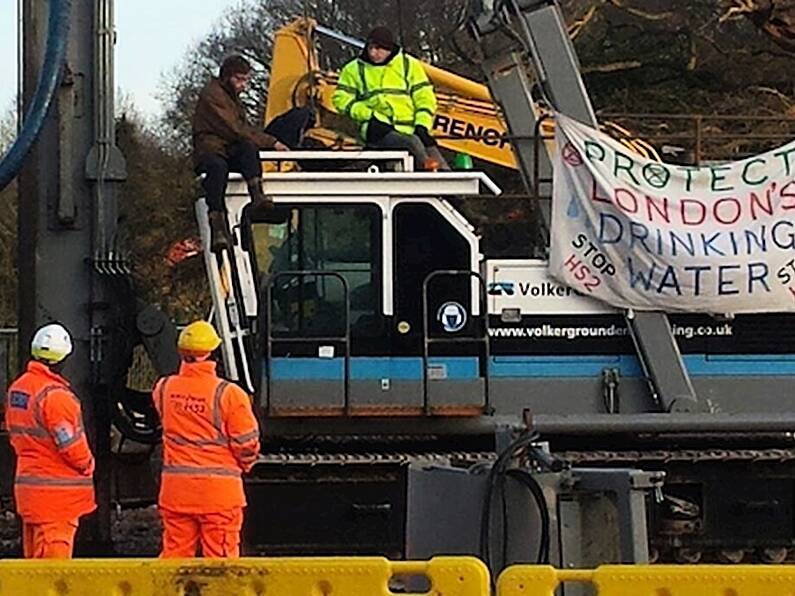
[{"x1": 5, "y1": 323, "x2": 96, "y2": 559}]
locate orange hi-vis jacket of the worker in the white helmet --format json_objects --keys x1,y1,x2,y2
[{"x1": 5, "y1": 361, "x2": 96, "y2": 523}]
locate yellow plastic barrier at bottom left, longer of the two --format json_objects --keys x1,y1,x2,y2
[{"x1": 0, "y1": 557, "x2": 490, "y2": 596}]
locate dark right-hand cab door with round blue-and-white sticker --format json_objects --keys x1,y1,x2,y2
[{"x1": 392, "y1": 200, "x2": 488, "y2": 415}]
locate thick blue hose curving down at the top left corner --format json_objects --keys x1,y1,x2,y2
[{"x1": 0, "y1": 0, "x2": 72, "y2": 190}]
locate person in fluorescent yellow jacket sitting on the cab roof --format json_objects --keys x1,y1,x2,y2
[{"x1": 332, "y1": 27, "x2": 449, "y2": 170}]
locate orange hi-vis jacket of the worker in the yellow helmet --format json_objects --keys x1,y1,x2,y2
[{"x1": 157, "y1": 360, "x2": 259, "y2": 513}]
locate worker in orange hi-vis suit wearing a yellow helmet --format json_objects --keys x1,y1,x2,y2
[{"x1": 157, "y1": 321, "x2": 259, "y2": 558}]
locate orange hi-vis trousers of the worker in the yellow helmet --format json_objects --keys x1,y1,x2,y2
[{"x1": 160, "y1": 507, "x2": 243, "y2": 559}]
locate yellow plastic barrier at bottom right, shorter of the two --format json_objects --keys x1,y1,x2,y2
[{"x1": 497, "y1": 565, "x2": 795, "y2": 596}]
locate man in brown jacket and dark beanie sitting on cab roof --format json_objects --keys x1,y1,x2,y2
[{"x1": 193, "y1": 55, "x2": 289, "y2": 252}]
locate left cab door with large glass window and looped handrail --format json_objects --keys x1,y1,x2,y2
[{"x1": 251, "y1": 202, "x2": 384, "y2": 416}]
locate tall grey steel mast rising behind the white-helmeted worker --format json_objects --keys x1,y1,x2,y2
[{"x1": 18, "y1": 0, "x2": 128, "y2": 556}]
